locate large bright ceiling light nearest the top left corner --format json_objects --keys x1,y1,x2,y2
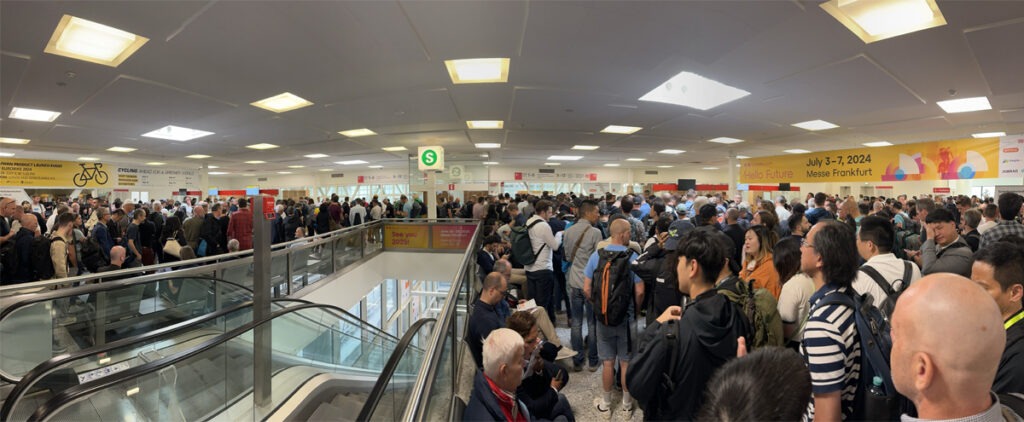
[{"x1": 43, "y1": 14, "x2": 150, "y2": 68}]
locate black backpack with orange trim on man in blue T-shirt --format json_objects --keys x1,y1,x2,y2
[{"x1": 590, "y1": 249, "x2": 633, "y2": 327}]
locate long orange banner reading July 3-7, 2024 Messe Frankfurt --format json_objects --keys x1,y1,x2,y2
[{"x1": 739, "y1": 138, "x2": 1000, "y2": 183}]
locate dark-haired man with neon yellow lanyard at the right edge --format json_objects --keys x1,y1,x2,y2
[{"x1": 971, "y1": 242, "x2": 1024, "y2": 393}]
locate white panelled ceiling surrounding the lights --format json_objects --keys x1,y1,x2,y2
[{"x1": 0, "y1": 1, "x2": 1024, "y2": 173}]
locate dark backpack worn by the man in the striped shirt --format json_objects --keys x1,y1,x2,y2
[{"x1": 801, "y1": 292, "x2": 913, "y2": 421}]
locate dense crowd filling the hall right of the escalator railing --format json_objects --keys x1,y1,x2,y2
[{"x1": 468, "y1": 192, "x2": 1024, "y2": 421}]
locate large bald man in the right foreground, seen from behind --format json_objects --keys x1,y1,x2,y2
[{"x1": 890, "y1": 272, "x2": 1020, "y2": 421}]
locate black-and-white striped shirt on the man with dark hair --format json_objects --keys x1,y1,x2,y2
[{"x1": 800, "y1": 285, "x2": 860, "y2": 420}]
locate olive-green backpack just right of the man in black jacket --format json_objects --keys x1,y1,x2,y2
[{"x1": 718, "y1": 278, "x2": 784, "y2": 350}]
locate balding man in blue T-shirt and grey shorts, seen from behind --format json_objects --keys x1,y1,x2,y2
[{"x1": 583, "y1": 218, "x2": 644, "y2": 412}]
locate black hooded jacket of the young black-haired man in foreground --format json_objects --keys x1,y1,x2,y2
[{"x1": 626, "y1": 289, "x2": 753, "y2": 420}]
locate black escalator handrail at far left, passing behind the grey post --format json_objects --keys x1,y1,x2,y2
[{"x1": 0, "y1": 299, "x2": 299, "y2": 421}]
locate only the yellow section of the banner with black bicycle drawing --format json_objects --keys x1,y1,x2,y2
[{"x1": 0, "y1": 158, "x2": 111, "y2": 187}]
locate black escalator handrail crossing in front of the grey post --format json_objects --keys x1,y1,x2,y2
[{"x1": 29, "y1": 303, "x2": 399, "y2": 422}]
